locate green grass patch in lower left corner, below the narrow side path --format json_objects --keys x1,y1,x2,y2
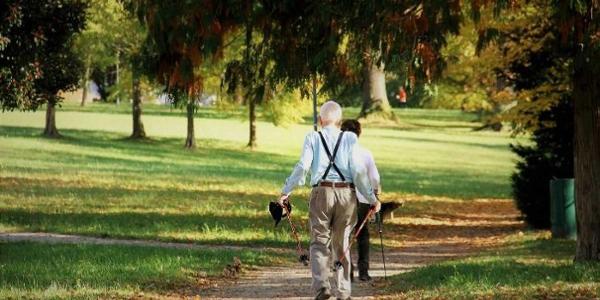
[{"x1": 0, "y1": 242, "x2": 286, "y2": 299}]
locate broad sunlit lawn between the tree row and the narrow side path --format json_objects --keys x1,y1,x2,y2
[{"x1": 0, "y1": 104, "x2": 515, "y2": 246}]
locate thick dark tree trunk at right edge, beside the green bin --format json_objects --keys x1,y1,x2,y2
[{"x1": 573, "y1": 45, "x2": 600, "y2": 261}]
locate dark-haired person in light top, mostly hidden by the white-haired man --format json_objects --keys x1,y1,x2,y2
[{"x1": 342, "y1": 120, "x2": 381, "y2": 281}]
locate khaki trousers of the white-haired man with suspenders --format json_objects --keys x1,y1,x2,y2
[{"x1": 308, "y1": 186, "x2": 358, "y2": 299}]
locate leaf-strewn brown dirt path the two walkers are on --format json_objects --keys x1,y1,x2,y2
[{"x1": 201, "y1": 199, "x2": 523, "y2": 299}]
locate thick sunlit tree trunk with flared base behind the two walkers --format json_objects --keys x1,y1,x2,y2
[{"x1": 360, "y1": 52, "x2": 392, "y2": 118}]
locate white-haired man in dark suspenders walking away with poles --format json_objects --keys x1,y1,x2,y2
[{"x1": 278, "y1": 101, "x2": 381, "y2": 299}]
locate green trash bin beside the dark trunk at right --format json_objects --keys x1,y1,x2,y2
[{"x1": 550, "y1": 178, "x2": 577, "y2": 240}]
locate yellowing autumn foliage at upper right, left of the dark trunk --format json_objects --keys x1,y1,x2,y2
[{"x1": 425, "y1": 1, "x2": 570, "y2": 133}]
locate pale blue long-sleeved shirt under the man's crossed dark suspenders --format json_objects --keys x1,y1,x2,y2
[{"x1": 281, "y1": 125, "x2": 377, "y2": 204}]
